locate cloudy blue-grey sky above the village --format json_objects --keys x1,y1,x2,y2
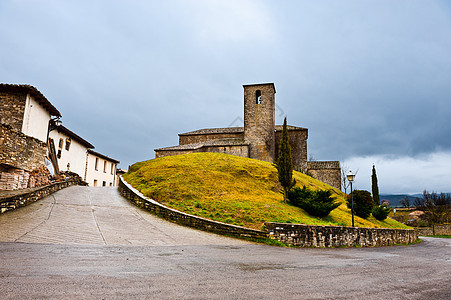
[{"x1": 0, "y1": 0, "x2": 451, "y2": 193}]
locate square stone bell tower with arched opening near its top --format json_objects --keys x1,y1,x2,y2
[{"x1": 243, "y1": 83, "x2": 276, "y2": 162}]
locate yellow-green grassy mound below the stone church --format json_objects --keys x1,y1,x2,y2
[{"x1": 124, "y1": 153, "x2": 407, "y2": 229}]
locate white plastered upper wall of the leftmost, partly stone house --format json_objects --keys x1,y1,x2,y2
[{"x1": 22, "y1": 94, "x2": 51, "y2": 142}]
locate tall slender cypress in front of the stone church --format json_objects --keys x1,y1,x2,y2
[{"x1": 276, "y1": 118, "x2": 296, "y2": 202}]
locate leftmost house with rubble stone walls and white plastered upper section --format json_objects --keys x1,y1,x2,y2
[{"x1": 0, "y1": 84, "x2": 61, "y2": 190}]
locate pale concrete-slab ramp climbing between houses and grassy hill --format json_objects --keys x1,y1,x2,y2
[{"x1": 0, "y1": 186, "x2": 246, "y2": 246}]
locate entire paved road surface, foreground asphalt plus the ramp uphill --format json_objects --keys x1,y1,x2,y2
[{"x1": 0, "y1": 188, "x2": 451, "y2": 299}]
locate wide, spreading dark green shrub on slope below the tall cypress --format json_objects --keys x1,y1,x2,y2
[{"x1": 288, "y1": 186, "x2": 340, "y2": 218}]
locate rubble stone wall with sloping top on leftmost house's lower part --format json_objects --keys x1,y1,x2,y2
[{"x1": 0, "y1": 124, "x2": 46, "y2": 171}]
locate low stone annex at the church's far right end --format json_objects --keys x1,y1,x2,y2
[{"x1": 307, "y1": 161, "x2": 341, "y2": 190}]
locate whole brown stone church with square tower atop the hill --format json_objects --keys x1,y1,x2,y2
[{"x1": 155, "y1": 83, "x2": 341, "y2": 189}]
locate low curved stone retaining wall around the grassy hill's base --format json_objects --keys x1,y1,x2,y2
[{"x1": 119, "y1": 177, "x2": 418, "y2": 247}]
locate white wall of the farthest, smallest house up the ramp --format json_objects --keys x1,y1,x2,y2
[{"x1": 85, "y1": 153, "x2": 117, "y2": 186}]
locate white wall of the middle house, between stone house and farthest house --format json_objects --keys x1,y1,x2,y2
[{"x1": 49, "y1": 129, "x2": 88, "y2": 178}]
